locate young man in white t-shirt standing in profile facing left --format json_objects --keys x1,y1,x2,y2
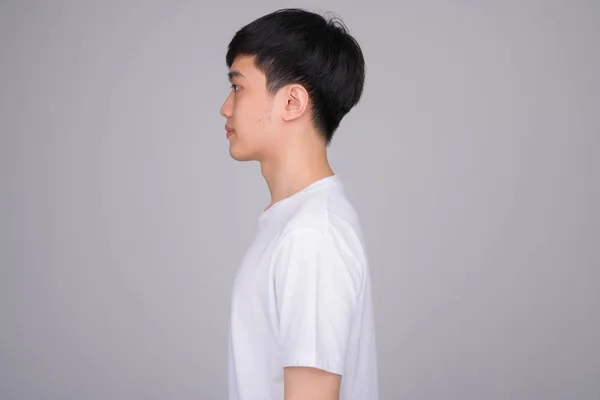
[{"x1": 221, "y1": 9, "x2": 378, "y2": 400}]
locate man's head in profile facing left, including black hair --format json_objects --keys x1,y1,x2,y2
[{"x1": 221, "y1": 9, "x2": 365, "y2": 161}]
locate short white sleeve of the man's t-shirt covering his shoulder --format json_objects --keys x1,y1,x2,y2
[{"x1": 273, "y1": 229, "x2": 362, "y2": 375}]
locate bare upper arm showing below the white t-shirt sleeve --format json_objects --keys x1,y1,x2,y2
[{"x1": 283, "y1": 367, "x2": 341, "y2": 400}]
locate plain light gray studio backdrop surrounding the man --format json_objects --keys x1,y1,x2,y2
[{"x1": 0, "y1": 0, "x2": 600, "y2": 400}]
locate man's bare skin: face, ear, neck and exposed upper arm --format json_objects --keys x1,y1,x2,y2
[{"x1": 220, "y1": 57, "x2": 341, "y2": 400}]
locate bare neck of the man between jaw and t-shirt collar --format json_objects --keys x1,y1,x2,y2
[{"x1": 260, "y1": 134, "x2": 334, "y2": 211}]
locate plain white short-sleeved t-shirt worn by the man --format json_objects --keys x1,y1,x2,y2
[{"x1": 229, "y1": 175, "x2": 378, "y2": 400}]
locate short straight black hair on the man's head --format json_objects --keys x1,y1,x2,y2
[{"x1": 226, "y1": 8, "x2": 365, "y2": 144}]
